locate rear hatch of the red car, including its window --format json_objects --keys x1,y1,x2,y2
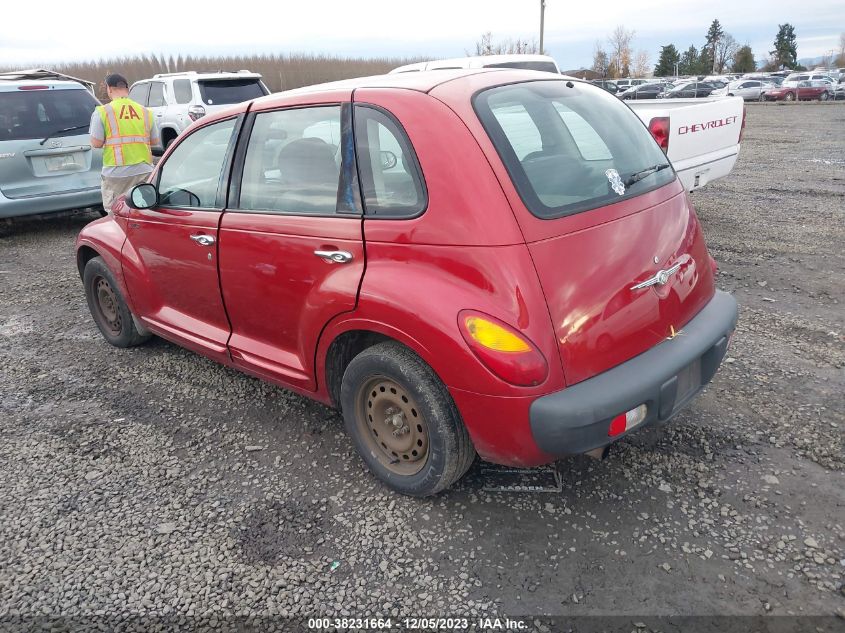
[{"x1": 475, "y1": 81, "x2": 714, "y2": 384}]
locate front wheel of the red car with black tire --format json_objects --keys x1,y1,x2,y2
[{"x1": 82, "y1": 257, "x2": 150, "y2": 347}]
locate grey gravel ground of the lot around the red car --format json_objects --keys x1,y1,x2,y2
[{"x1": 0, "y1": 104, "x2": 845, "y2": 630}]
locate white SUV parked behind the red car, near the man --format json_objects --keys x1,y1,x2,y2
[{"x1": 129, "y1": 70, "x2": 270, "y2": 150}]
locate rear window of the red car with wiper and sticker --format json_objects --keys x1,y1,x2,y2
[{"x1": 474, "y1": 80, "x2": 675, "y2": 219}]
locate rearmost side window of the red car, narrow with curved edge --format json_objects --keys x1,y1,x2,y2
[{"x1": 355, "y1": 106, "x2": 427, "y2": 217}]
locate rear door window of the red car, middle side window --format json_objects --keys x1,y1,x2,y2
[{"x1": 238, "y1": 106, "x2": 342, "y2": 215}]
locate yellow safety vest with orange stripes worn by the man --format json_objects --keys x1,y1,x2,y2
[{"x1": 97, "y1": 97, "x2": 153, "y2": 167}]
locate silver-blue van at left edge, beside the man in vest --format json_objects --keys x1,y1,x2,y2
[{"x1": 0, "y1": 71, "x2": 103, "y2": 218}]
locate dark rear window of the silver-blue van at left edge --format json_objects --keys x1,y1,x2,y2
[{"x1": 0, "y1": 89, "x2": 97, "y2": 141}]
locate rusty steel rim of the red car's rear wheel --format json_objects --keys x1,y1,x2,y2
[{"x1": 355, "y1": 376, "x2": 430, "y2": 476}]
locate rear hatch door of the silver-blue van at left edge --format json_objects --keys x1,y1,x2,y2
[{"x1": 0, "y1": 82, "x2": 102, "y2": 198}]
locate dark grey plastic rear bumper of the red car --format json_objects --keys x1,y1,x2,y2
[{"x1": 529, "y1": 290, "x2": 738, "y2": 455}]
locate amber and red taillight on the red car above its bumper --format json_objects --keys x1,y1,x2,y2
[{"x1": 458, "y1": 310, "x2": 549, "y2": 387}]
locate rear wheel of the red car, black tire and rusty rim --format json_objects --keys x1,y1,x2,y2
[{"x1": 340, "y1": 342, "x2": 475, "y2": 497}]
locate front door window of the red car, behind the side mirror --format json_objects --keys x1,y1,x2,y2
[{"x1": 158, "y1": 119, "x2": 235, "y2": 209}]
